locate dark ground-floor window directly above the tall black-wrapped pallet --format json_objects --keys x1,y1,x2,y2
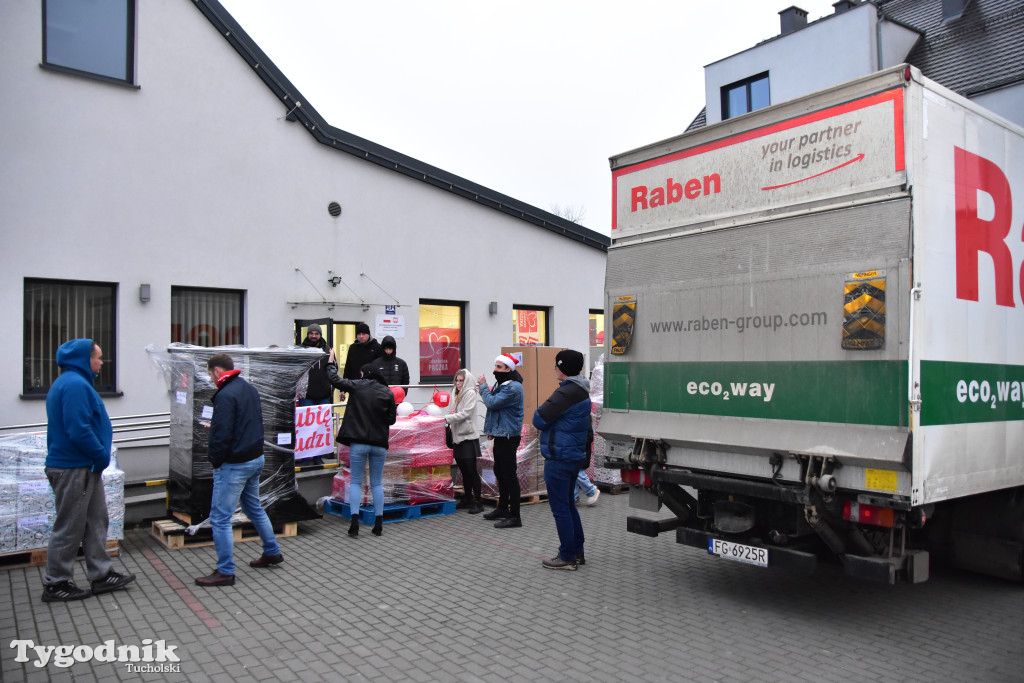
[{"x1": 171, "y1": 287, "x2": 245, "y2": 346}]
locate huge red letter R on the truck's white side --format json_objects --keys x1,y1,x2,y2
[{"x1": 953, "y1": 145, "x2": 1024, "y2": 307}]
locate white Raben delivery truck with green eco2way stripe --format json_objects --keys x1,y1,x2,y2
[{"x1": 598, "y1": 65, "x2": 1024, "y2": 583}]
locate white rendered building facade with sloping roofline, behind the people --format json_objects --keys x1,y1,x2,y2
[{"x1": 0, "y1": 0, "x2": 608, "y2": 481}]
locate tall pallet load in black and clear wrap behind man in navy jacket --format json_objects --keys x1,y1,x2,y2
[{"x1": 146, "y1": 344, "x2": 324, "y2": 531}]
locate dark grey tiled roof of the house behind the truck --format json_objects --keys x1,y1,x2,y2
[{"x1": 873, "y1": 0, "x2": 1024, "y2": 97}]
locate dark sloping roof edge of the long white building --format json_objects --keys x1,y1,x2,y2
[{"x1": 195, "y1": 0, "x2": 611, "y2": 251}]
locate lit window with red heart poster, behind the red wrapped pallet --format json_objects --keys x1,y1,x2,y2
[{"x1": 420, "y1": 299, "x2": 466, "y2": 383}]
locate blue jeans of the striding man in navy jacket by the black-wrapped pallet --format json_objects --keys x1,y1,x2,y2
[{"x1": 210, "y1": 456, "x2": 281, "y2": 574}]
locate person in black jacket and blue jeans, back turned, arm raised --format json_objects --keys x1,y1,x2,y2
[{"x1": 327, "y1": 350, "x2": 397, "y2": 537}]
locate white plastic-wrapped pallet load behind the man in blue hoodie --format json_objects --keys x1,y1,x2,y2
[{"x1": 0, "y1": 433, "x2": 125, "y2": 553}]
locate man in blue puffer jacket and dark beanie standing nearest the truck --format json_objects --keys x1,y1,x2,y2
[{"x1": 534, "y1": 349, "x2": 594, "y2": 570}]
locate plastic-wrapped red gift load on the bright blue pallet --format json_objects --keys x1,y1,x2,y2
[{"x1": 331, "y1": 415, "x2": 455, "y2": 506}]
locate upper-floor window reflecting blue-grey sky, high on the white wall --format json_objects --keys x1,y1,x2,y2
[{"x1": 43, "y1": 0, "x2": 135, "y2": 84}]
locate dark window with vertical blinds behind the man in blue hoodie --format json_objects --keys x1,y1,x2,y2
[{"x1": 23, "y1": 278, "x2": 118, "y2": 396}]
